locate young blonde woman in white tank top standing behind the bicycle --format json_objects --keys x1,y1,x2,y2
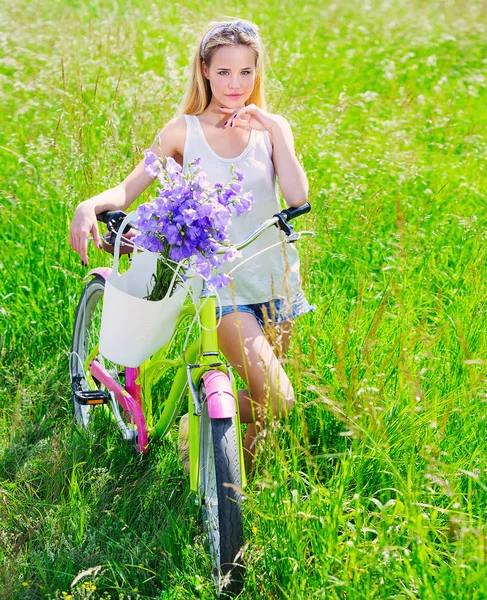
[{"x1": 70, "y1": 20, "x2": 311, "y2": 467}]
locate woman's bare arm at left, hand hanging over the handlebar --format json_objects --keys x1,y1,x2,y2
[{"x1": 69, "y1": 117, "x2": 186, "y2": 265}]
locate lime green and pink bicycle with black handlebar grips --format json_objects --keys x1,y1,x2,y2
[{"x1": 70, "y1": 203, "x2": 311, "y2": 594}]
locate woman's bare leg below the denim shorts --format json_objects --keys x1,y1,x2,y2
[{"x1": 218, "y1": 312, "x2": 294, "y2": 473}]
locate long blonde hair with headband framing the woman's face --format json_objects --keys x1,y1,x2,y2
[{"x1": 178, "y1": 19, "x2": 266, "y2": 115}]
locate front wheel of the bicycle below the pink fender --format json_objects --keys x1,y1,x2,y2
[{"x1": 200, "y1": 380, "x2": 244, "y2": 595}]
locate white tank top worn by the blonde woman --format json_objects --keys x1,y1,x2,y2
[{"x1": 183, "y1": 115, "x2": 301, "y2": 306}]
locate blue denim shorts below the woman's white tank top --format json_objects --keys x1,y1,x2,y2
[{"x1": 216, "y1": 292, "x2": 316, "y2": 329}]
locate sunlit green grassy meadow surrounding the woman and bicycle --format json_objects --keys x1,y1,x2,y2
[{"x1": 0, "y1": 0, "x2": 487, "y2": 600}]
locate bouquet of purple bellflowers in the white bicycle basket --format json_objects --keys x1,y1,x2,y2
[{"x1": 135, "y1": 150, "x2": 253, "y2": 287}]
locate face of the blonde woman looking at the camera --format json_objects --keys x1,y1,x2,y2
[{"x1": 203, "y1": 44, "x2": 255, "y2": 109}]
